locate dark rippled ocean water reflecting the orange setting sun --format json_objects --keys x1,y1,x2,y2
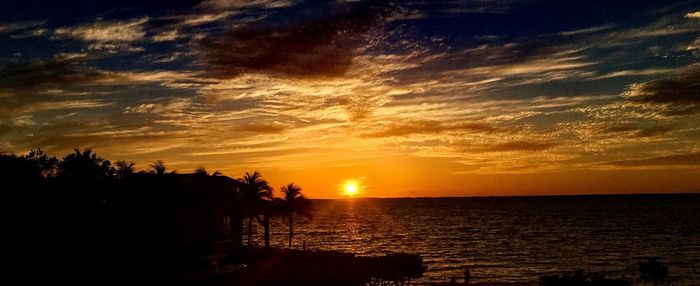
[{"x1": 256, "y1": 195, "x2": 700, "y2": 286}]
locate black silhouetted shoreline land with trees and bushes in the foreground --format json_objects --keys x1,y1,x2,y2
[{"x1": 0, "y1": 150, "x2": 684, "y2": 286}]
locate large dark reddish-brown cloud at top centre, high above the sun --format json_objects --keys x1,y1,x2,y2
[{"x1": 200, "y1": 3, "x2": 388, "y2": 78}]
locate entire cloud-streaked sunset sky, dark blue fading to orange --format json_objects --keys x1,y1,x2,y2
[{"x1": 0, "y1": 0, "x2": 700, "y2": 198}]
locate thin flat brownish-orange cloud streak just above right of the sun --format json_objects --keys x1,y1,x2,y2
[{"x1": 362, "y1": 120, "x2": 496, "y2": 138}]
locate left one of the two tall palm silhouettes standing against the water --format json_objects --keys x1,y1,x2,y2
[{"x1": 238, "y1": 171, "x2": 272, "y2": 246}]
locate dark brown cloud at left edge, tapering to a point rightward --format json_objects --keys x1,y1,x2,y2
[{"x1": 0, "y1": 53, "x2": 194, "y2": 118}]
